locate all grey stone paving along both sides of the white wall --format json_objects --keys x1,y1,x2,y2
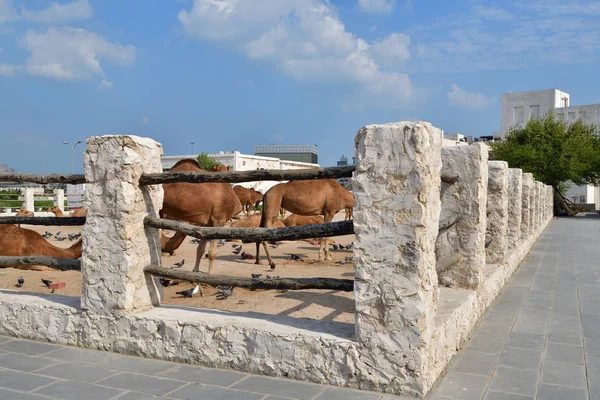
[{"x1": 0, "y1": 213, "x2": 600, "y2": 400}]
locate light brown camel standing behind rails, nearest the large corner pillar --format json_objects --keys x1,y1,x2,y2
[{"x1": 256, "y1": 179, "x2": 347, "y2": 266}]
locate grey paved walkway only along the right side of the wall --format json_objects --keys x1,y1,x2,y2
[{"x1": 431, "y1": 213, "x2": 600, "y2": 400}]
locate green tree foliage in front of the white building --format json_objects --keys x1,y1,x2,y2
[{"x1": 491, "y1": 113, "x2": 600, "y2": 190}]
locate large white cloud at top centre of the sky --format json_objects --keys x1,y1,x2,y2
[{"x1": 178, "y1": 0, "x2": 412, "y2": 100}]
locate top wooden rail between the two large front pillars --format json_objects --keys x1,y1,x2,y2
[{"x1": 140, "y1": 165, "x2": 355, "y2": 185}]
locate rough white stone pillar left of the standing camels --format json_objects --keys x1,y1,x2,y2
[{"x1": 81, "y1": 135, "x2": 163, "y2": 315}]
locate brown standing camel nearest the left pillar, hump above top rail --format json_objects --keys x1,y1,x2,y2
[{"x1": 160, "y1": 158, "x2": 242, "y2": 274}]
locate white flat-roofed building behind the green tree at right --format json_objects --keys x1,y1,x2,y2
[{"x1": 498, "y1": 89, "x2": 600, "y2": 209}]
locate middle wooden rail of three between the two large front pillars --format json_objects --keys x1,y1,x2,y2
[{"x1": 144, "y1": 217, "x2": 354, "y2": 242}]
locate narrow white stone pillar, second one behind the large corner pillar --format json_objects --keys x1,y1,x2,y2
[{"x1": 486, "y1": 161, "x2": 508, "y2": 264}]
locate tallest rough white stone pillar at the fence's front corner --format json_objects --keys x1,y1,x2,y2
[{"x1": 353, "y1": 122, "x2": 442, "y2": 395}]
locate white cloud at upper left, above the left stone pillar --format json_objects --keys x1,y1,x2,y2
[{"x1": 20, "y1": 27, "x2": 135, "y2": 80}]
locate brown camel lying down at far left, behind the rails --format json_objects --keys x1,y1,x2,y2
[{"x1": 0, "y1": 224, "x2": 82, "y2": 260}]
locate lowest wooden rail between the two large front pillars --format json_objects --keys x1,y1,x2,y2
[{"x1": 144, "y1": 265, "x2": 354, "y2": 292}]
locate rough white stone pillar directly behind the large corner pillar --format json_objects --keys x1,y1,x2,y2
[{"x1": 435, "y1": 143, "x2": 488, "y2": 289}]
